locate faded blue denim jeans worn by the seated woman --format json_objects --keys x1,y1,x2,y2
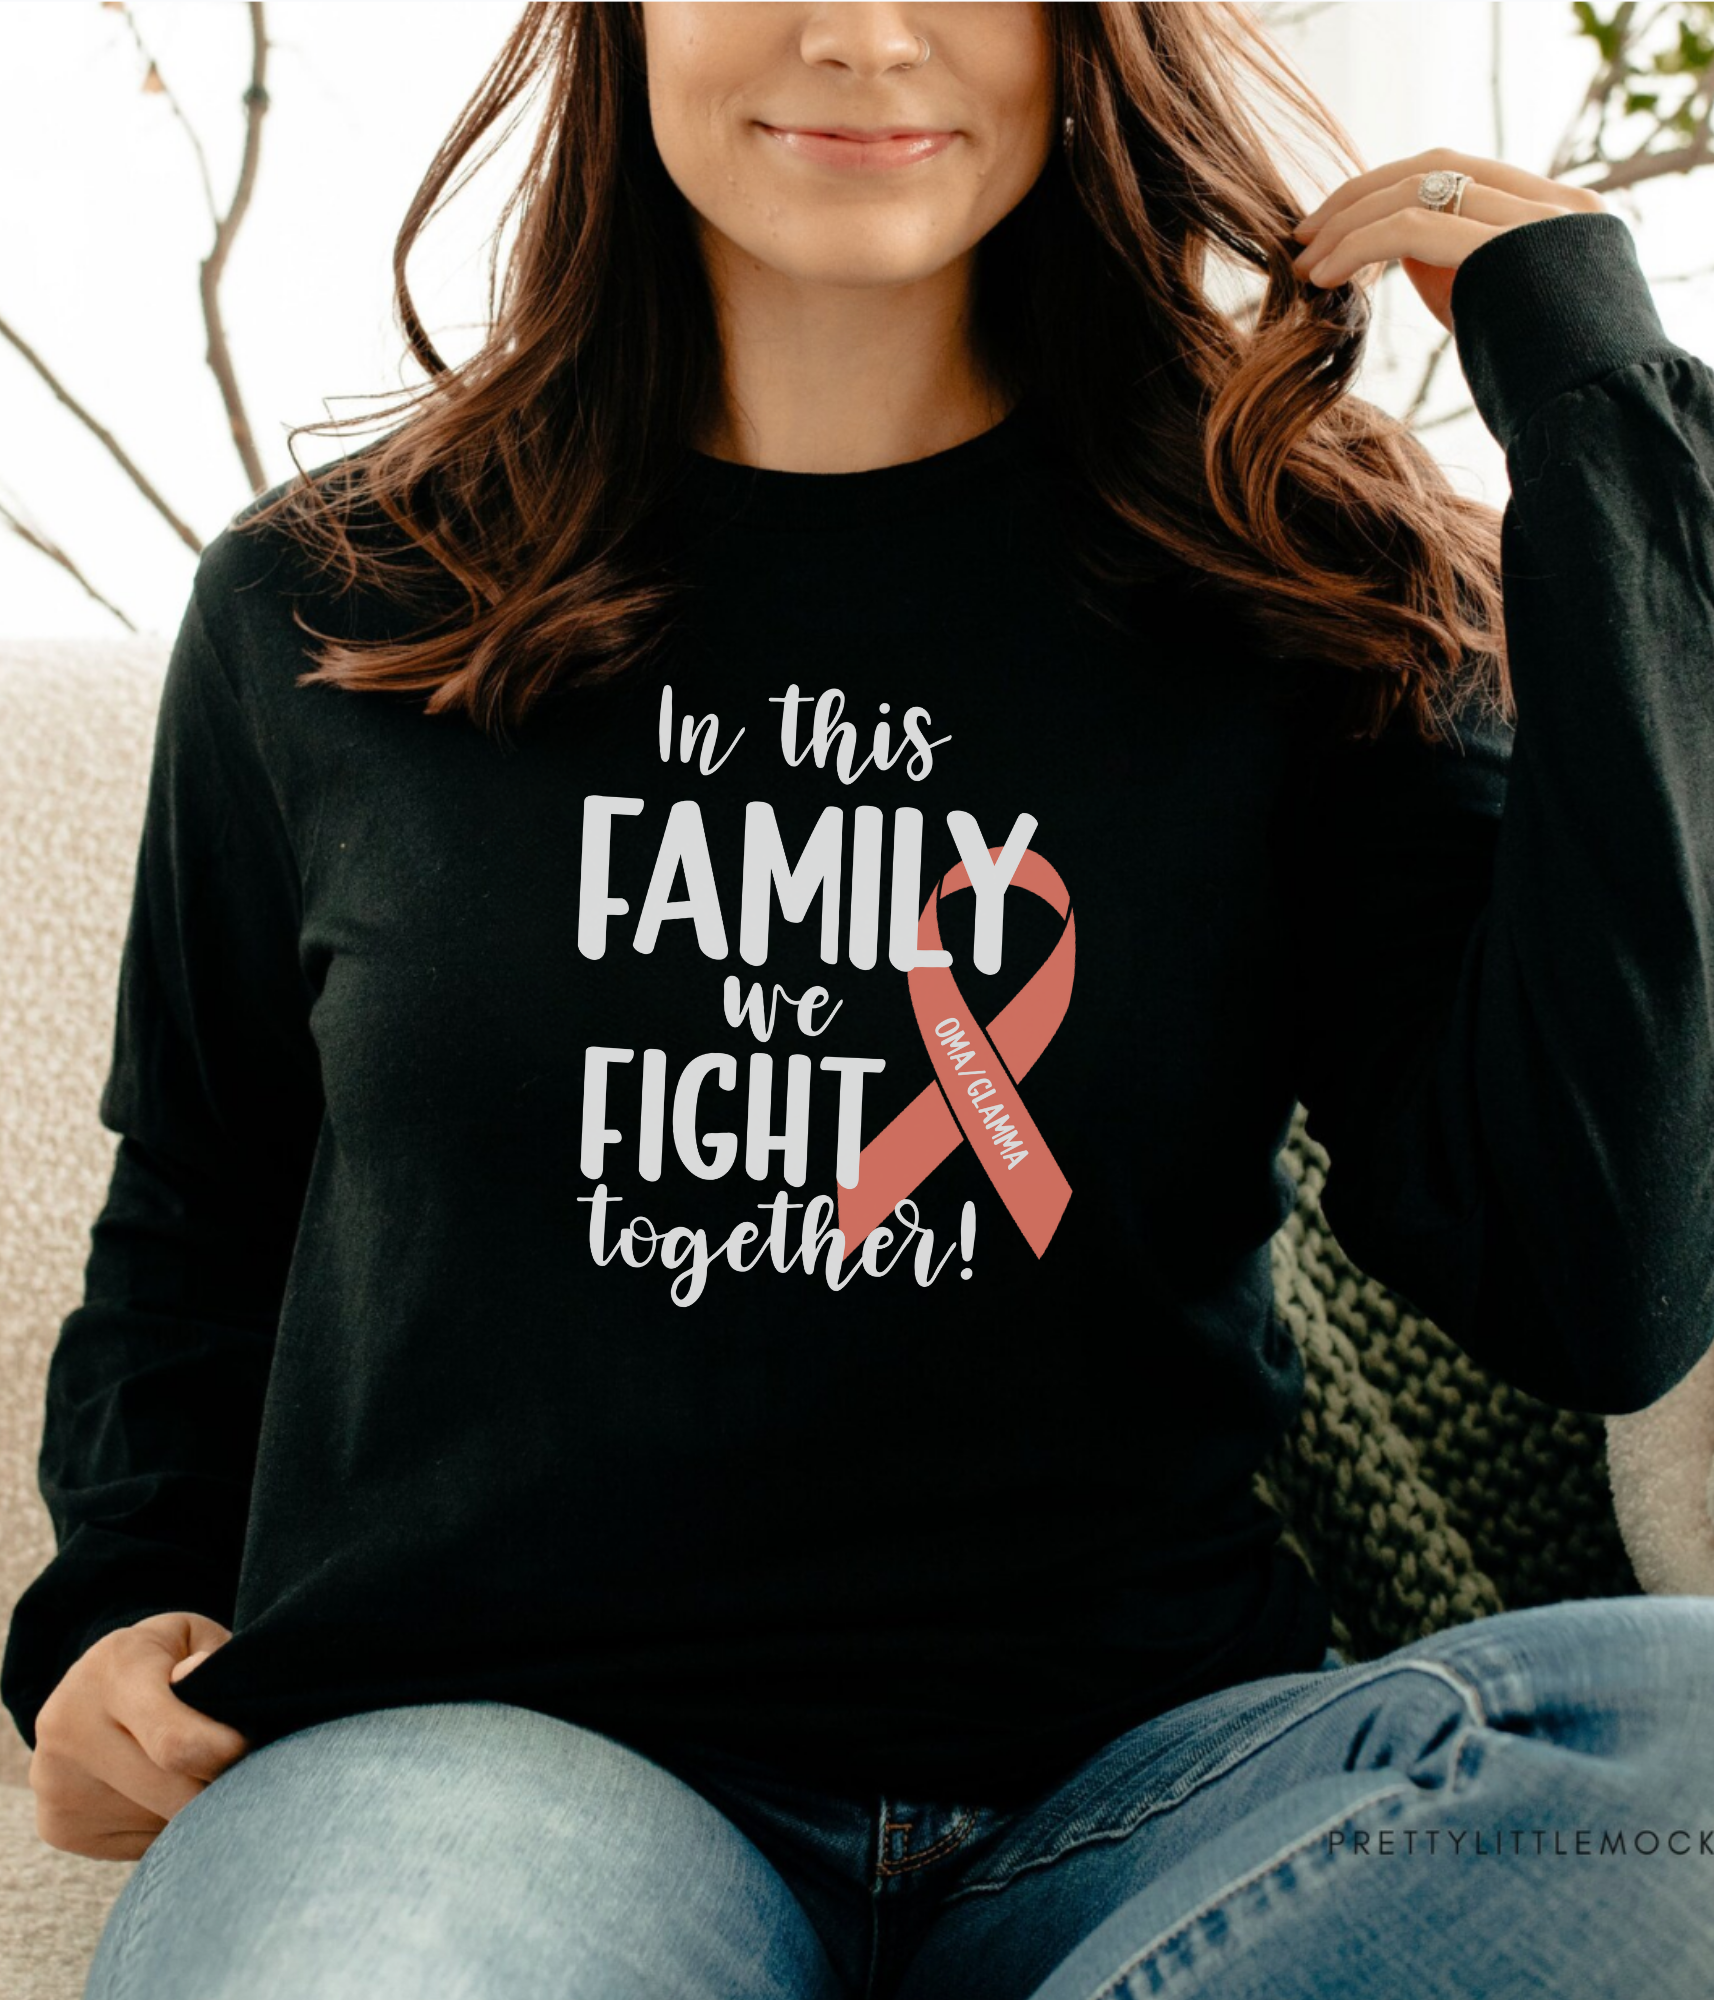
[{"x1": 86, "y1": 1596, "x2": 1714, "y2": 2000}]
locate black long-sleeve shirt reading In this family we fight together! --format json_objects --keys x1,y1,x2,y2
[{"x1": 0, "y1": 214, "x2": 1714, "y2": 1798}]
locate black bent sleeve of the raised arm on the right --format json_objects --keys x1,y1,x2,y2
[{"x1": 1288, "y1": 212, "x2": 1714, "y2": 1416}]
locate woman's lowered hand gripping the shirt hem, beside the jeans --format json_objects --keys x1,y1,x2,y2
[{"x1": 30, "y1": 1612, "x2": 250, "y2": 1862}]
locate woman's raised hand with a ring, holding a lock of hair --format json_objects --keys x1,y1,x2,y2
[{"x1": 1292, "y1": 146, "x2": 1606, "y2": 332}]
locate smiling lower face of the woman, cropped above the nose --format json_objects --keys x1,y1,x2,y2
[{"x1": 642, "y1": 0, "x2": 1056, "y2": 286}]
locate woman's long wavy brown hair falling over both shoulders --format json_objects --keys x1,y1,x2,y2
[{"x1": 244, "y1": 0, "x2": 1514, "y2": 740}]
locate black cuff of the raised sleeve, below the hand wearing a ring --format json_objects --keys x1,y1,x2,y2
[{"x1": 1452, "y1": 208, "x2": 1684, "y2": 452}]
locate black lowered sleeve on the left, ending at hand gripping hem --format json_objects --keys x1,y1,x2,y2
[{"x1": 0, "y1": 544, "x2": 322, "y2": 1748}]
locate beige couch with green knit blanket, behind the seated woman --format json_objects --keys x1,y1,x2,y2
[{"x1": 0, "y1": 638, "x2": 1714, "y2": 2000}]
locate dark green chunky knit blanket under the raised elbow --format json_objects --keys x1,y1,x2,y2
[{"x1": 1256, "y1": 1106, "x2": 1640, "y2": 1660}]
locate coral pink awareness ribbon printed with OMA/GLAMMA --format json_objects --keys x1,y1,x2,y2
[{"x1": 838, "y1": 848, "x2": 1076, "y2": 1256}]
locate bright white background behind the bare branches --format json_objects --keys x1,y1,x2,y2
[{"x1": 0, "y1": 0, "x2": 1714, "y2": 634}]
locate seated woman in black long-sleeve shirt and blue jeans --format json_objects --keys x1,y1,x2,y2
[{"x1": 6, "y1": 0, "x2": 1714, "y2": 2000}]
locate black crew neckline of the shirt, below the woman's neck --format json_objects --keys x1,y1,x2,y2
[{"x1": 678, "y1": 394, "x2": 1034, "y2": 530}]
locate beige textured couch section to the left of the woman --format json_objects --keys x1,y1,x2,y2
[{"x1": 0, "y1": 640, "x2": 168, "y2": 2000}]
